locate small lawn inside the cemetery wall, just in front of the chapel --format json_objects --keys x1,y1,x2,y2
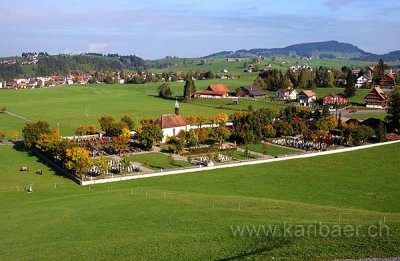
[{"x1": 129, "y1": 153, "x2": 191, "y2": 170}]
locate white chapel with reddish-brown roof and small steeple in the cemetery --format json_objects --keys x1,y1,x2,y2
[{"x1": 154, "y1": 101, "x2": 190, "y2": 143}]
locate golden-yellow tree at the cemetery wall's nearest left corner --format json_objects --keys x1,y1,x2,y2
[{"x1": 65, "y1": 147, "x2": 92, "y2": 180}]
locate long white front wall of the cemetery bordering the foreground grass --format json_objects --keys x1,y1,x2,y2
[{"x1": 81, "y1": 140, "x2": 400, "y2": 186}]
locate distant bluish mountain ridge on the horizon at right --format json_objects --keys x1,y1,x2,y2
[{"x1": 203, "y1": 41, "x2": 400, "y2": 61}]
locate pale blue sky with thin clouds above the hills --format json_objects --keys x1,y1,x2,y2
[{"x1": 0, "y1": 0, "x2": 400, "y2": 59}]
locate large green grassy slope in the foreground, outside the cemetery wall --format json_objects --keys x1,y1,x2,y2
[{"x1": 0, "y1": 144, "x2": 400, "y2": 260}]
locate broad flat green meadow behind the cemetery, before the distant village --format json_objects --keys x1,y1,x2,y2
[{"x1": 0, "y1": 79, "x2": 282, "y2": 136}]
